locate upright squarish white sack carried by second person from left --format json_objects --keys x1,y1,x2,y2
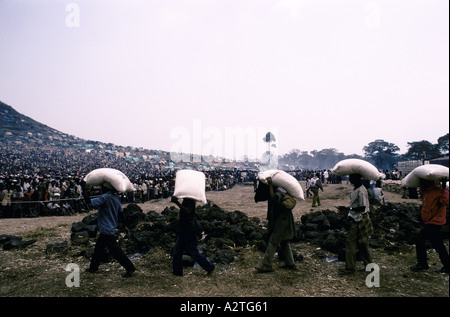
[{"x1": 173, "y1": 170, "x2": 206, "y2": 204}]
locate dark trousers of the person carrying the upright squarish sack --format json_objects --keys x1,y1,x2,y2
[{"x1": 173, "y1": 233, "x2": 214, "y2": 275}]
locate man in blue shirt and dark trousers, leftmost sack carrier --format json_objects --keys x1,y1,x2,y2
[{"x1": 87, "y1": 185, "x2": 136, "y2": 277}]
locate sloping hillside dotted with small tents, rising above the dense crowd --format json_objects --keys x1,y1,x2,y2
[{"x1": 0, "y1": 101, "x2": 251, "y2": 174}]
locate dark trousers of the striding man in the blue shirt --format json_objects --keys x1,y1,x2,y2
[{"x1": 89, "y1": 233, "x2": 134, "y2": 272}]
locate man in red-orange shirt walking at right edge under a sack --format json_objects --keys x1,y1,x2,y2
[{"x1": 411, "y1": 180, "x2": 449, "y2": 273}]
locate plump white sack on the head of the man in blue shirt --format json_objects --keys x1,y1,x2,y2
[{"x1": 84, "y1": 168, "x2": 135, "y2": 193}]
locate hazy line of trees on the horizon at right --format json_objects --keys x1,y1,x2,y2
[{"x1": 278, "y1": 133, "x2": 449, "y2": 170}]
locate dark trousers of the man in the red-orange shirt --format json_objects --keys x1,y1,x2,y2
[{"x1": 416, "y1": 224, "x2": 448, "y2": 270}]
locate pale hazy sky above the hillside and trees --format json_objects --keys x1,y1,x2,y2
[{"x1": 0, "y1": 0, "x2": 449, "y2": 158}]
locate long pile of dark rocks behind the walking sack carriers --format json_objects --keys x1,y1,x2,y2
[{"x1": 62, "y1": 202, "x2": 449, "y2": 264}]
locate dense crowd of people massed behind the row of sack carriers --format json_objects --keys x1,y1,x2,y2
[{"x1": 0, "y1": 143, "x2": 400, "y2": 217}]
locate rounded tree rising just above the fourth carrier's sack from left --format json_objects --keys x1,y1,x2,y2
[{"x1": 363, "y1": 139, "x2": 400, "y2": 170}]
